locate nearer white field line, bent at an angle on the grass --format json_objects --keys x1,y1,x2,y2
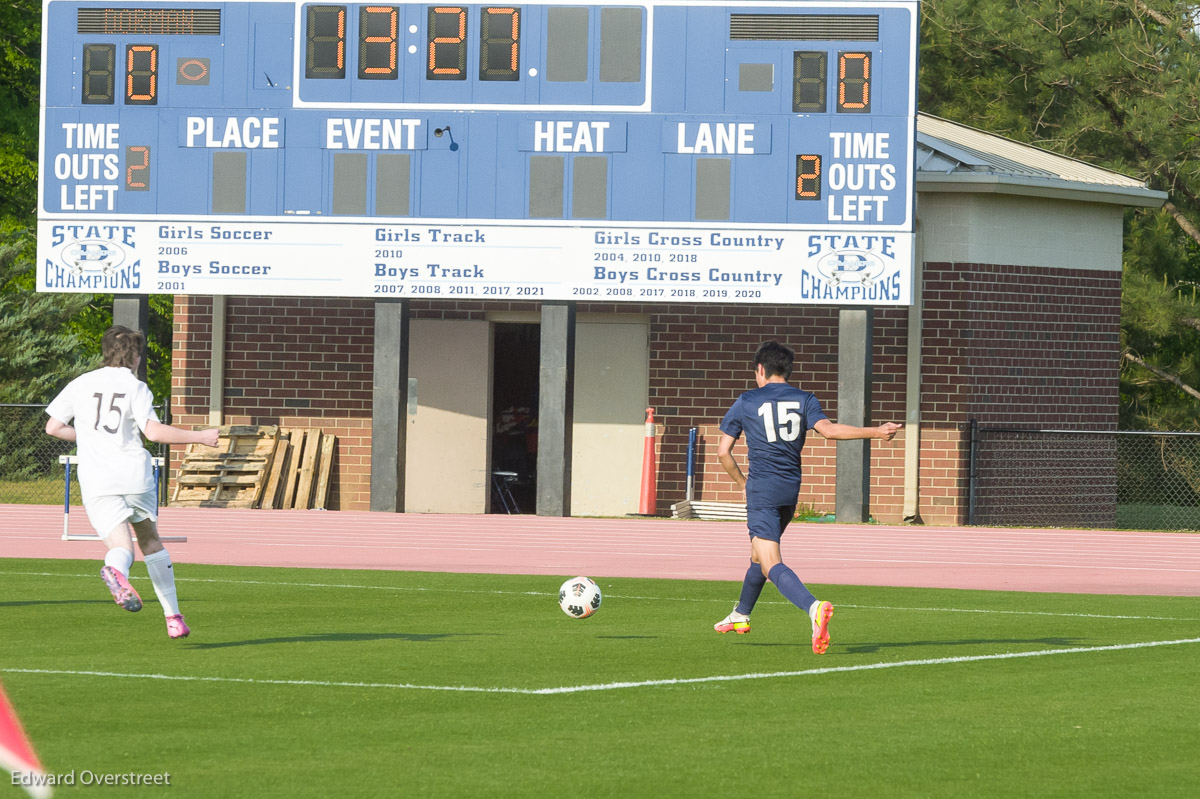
[{"x1": 0, "y1": 638, "x2": 1200, "y2": 696}]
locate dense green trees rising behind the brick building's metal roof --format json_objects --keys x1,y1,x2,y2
[{"x1": 920, "y1": 0, "x2": 1200, "y2": 429}]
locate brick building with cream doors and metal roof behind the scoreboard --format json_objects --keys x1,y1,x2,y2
[{"x1": 166, "y1": 115, "x2": 1164, "y2": 524}]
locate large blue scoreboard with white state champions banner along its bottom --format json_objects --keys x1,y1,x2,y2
[{"x1": 37, "y1": 0, "x2": 918, "y2": 305}]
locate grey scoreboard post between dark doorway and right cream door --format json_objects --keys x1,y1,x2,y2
[{"x1": 538, "y1": 302, "x2": 575, "y2": 516}]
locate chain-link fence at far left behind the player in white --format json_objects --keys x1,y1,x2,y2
[{"x1": 0, "y1": 403, "x2": 167, "y2": 505}]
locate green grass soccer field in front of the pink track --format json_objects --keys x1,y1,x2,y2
[{"x1": 0, "y1": 559, "x2": 1200, "y2": 799}]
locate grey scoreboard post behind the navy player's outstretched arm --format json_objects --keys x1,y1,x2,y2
[{"x1": 834, "y1": 307, "x2": 875, "y2": 524}]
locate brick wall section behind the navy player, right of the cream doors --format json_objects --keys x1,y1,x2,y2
[{"x1": 650, "y1": 305, "x2": 907, "y2": 519}]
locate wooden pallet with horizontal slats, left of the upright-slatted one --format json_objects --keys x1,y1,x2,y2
[{"x1": 170, "y1": 425, "x2": 280, "y2": 507}]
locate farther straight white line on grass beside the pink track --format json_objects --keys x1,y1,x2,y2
[{"x1": 0, "y1": 571, "x2": 1200, "y2": 621}]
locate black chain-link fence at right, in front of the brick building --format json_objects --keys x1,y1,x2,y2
[{"x1": 967, "y1": 421, "x2": 1200, "y2": 530}]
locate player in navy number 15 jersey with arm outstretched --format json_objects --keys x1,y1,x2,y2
[{"x1": 714, "y1": 341, "x2": 900, "y2": 655}]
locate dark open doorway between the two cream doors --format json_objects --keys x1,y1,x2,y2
[{"x1": 492, "y1": 323, "x2": 541, "y2": 513}]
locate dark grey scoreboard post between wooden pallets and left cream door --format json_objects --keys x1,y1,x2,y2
[{"x1": 371, "y1": 300, "x2": 409, "y2": 513}]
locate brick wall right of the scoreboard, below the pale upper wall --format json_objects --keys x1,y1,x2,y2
[{"x1": 920, "y1": 264, "x2": 1121, "y2": 523}]
